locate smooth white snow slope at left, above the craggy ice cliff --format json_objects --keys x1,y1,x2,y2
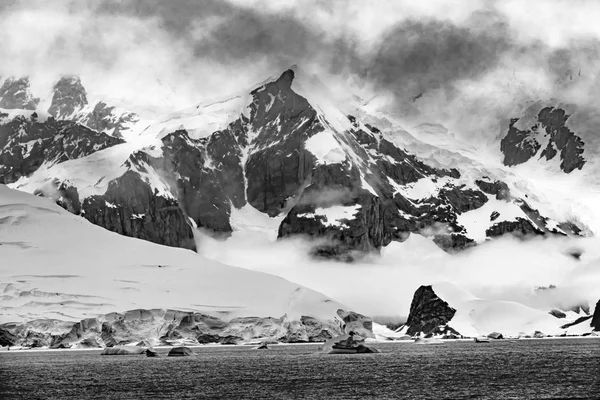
[{"x1": 0, "y1": 185, "x2": 356, "y2": 346}]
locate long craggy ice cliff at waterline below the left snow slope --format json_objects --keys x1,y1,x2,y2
[{"x1": 0, "y1": 309, "x2": 366, "y2": 350}]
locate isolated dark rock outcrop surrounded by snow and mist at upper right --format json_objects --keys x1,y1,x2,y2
[{"x1": 500, "y1": 107, "x2": 585, "y2": 174}]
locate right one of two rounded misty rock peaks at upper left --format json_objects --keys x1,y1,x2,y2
[{"x1": 48, "y1": 76, "x2": 88, "y2": 119}]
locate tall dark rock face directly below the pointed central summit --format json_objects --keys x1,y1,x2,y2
[{"x1": 245, "y1": 70, "x2": 324, "y2": 216}]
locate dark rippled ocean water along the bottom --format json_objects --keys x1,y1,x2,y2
[{"x1": 0, "y1": 339, "x2": 600, "y2": 400}]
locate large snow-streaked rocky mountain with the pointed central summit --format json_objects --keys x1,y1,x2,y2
[{"x1": 3, "y1": 68, "x2": 590, "y2": 260}]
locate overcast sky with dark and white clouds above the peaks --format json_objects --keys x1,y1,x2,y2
[{"x1": 0, "y1": 0, "x2": 600, "y2": 120}]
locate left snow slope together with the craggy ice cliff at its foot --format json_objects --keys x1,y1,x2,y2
[{"x1": 0, "y1": 185, "x2": 357, "y2": 347}]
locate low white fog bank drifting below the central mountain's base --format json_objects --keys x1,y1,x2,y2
[{"x1": 197, "y1": 223, "x2": 600, "y2": 321}]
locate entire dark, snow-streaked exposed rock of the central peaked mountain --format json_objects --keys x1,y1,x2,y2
[{"x1": 156, "y1": 70, "x2": 516, "y2": 255}]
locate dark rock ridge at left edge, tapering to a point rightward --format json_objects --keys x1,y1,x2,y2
[{"x1": 0, "y1": 113, "x2": 122, "y2": 184}]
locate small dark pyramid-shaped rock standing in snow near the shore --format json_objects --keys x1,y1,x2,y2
[{"x1": 406, "y1": 286, "x2": 456, "y2": 336}]
